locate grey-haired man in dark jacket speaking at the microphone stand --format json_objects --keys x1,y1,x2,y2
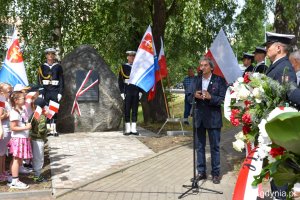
[{"x1": 188, "y1": 57, "x2": 227, "y2": 184}]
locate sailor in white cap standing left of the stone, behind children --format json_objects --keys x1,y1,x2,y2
[{"x1": 38, "y1": 48, "x2": 64, "y2": 136}]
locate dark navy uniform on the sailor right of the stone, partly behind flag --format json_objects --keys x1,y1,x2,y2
[{"x1": 118, "y1": 63, "x2": 141, "y2": 123}]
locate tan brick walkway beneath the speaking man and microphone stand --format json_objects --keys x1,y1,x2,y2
[{"x1": 55, "y1": 127, "x2": 243, "y2": 200}]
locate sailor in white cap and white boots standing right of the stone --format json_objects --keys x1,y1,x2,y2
[{"x1": 118, "y1": 51, "x2": 142, "y2": 135}]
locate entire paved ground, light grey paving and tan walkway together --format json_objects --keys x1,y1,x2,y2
[{"x1": 0, "y1": 126, "x2": 244, "y2": 200}]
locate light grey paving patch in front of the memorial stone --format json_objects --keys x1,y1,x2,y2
[{"x1": 49, "y1": 131, "x2": 154, "y2": 196}]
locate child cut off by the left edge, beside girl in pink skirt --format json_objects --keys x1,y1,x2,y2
[{"x1": 0, "y1": 83, "x2": 12, "y2": 181}]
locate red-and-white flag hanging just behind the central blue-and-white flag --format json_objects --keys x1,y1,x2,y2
[{"x1": 148, "y1": 37, "x2": 168, "y2": 101}]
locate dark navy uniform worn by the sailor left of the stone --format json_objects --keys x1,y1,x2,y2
[{"x1": 38, "y1": 63, "x2": 64, "y2": 119}]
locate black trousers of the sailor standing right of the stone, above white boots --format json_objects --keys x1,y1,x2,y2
[{"x1": 125, "y1": 92, "x2": 139, "y2": 123}]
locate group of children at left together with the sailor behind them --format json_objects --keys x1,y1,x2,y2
[{"x1": 0, "y1": 48, "x2": 63, "y2": 189}]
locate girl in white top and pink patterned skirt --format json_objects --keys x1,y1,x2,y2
[{"x1": 8, "y1": 92, "x2": 32, "y2": 189}]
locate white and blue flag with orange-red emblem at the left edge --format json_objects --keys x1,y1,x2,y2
[{"x1": 0, "y1": 31, "x2": 28, "y2": 86}]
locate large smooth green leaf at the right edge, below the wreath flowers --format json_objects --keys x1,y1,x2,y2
[{"x1": 266, "y1": 112, "x2": 300, "y2": 155}]
